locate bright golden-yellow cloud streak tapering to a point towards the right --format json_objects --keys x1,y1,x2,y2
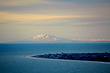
[{"x1": 0, "y1": 12, "x2": 93, "y2": 23}]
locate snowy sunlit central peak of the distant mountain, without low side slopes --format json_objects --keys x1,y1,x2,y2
[{"x1": 28, "y1": 34, "x2": 72, "y2": 43}]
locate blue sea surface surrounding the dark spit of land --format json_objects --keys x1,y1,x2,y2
[{"x1": 0, "y1": 43, "x2": 110, "y2": 73}]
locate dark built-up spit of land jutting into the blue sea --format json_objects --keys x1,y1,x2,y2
[{"x1": 31, "y1": 52, "x2": 110, "y2": 62}]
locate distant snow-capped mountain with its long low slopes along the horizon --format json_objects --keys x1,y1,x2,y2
[{"x1": 9, "y1": 34, "x2": 108, "y2": 43}]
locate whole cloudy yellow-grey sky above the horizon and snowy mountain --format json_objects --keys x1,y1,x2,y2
[{"x1": 0, "y1": 0, "x2": 110, "y2": 43}]
